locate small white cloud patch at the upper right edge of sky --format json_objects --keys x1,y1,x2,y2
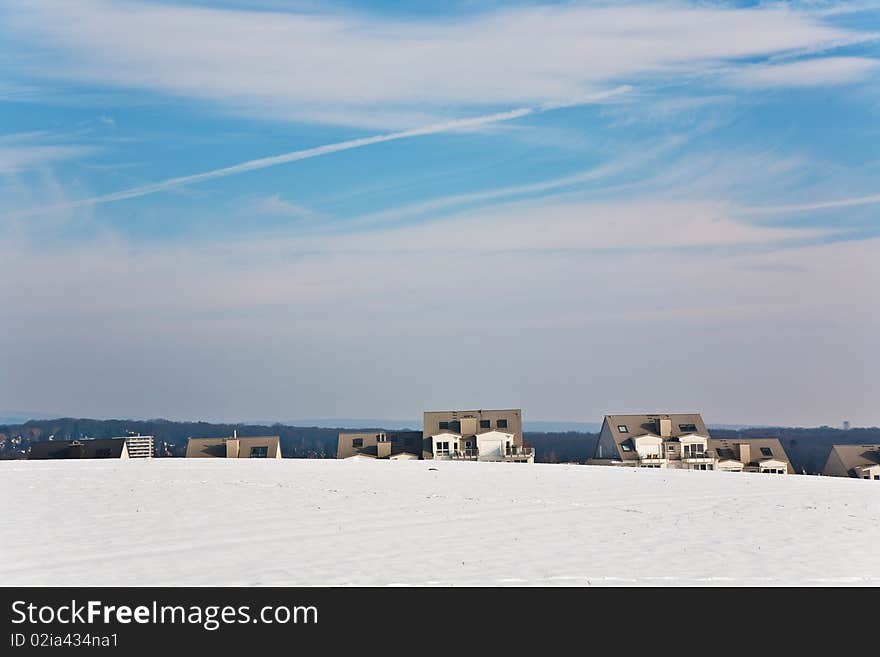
[{"x1": 729, "y1": 57, "x2": 880, "y2": 88}]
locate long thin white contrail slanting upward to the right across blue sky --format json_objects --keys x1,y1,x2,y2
[{"x1": 13, "y1": 85, "x2": 631, "y2": 217}]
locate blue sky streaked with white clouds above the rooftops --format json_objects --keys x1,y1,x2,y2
[{"x1": 0, "y1": 0, "x2": 880, "y2": 424}]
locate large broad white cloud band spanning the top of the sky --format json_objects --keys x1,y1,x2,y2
[{"x1": 3, "y1": 0, "x2": 858, "y2": 127}]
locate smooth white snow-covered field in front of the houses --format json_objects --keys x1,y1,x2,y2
[{"x1": 0, "y1": 459, "x2": 880, "y2": 586}]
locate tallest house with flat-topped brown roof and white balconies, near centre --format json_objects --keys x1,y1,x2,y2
[{"x1": 422, "y1": 408, "x2": 535, "y2": 463}]
